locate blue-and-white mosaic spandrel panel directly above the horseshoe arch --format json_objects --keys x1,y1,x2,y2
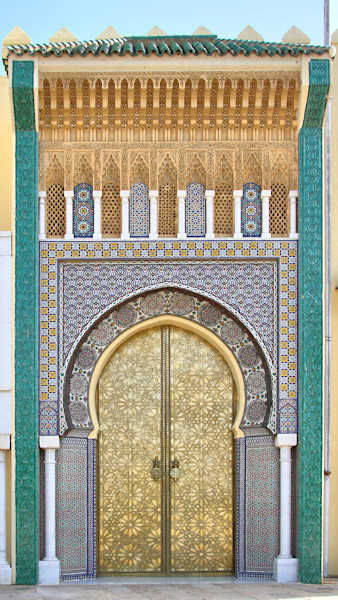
[{"x1": 59, "y1": 258, "x2": 278, "y2": 366}]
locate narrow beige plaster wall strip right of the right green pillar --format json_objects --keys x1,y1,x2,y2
[{"x1": 329, "y1": 43, "x2": 338, "y2": 575}]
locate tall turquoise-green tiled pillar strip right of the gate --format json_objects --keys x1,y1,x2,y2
[{"x1": 298, "y1": 60, "x2": 330, "y2": 583}]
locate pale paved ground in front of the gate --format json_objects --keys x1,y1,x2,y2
[{"x1": 0, "y1": 578, "x2": 338, "y2": 600}]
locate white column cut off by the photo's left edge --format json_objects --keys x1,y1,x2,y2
[{"x1": 0, "y1": 435, "x2": 12, "y2": 585}]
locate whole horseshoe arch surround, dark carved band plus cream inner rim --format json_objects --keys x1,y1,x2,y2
[{"x1": 60, "y1": 290, "x2": 276, "y2": 437}]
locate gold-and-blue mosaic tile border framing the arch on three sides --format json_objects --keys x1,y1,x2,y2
[{"x1": 40, "y1": 239, "x2": 297, "y2": 435}]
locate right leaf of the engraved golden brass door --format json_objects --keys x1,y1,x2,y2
[{"x1": 170, "y1": 327, "x2": 233, "y2": 573}]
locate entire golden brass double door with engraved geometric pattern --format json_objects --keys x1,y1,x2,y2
[{"x1": 98, "y1": 326, "x2": 233, "y2": 575}]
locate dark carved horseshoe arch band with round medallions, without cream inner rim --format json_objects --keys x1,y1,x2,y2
[{"x1": 60, "y1": 288, "x2": 276, "y2": 434}]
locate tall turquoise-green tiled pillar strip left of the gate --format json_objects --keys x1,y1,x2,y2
[{"x1": 13, "y1": 61, "x2": 38, "y2": 584}]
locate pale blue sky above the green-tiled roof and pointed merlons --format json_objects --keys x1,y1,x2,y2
[{"x1": 0, "y1": 0, "x2": 338, "y2": 74}]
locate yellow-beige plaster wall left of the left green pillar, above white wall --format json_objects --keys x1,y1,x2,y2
[{"x1": 0, "y1": 75, "x2": 13, "y2": 231}]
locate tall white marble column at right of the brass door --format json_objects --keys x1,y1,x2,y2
[{"x1": 274, "y1": 433, "x2": 298, "y2": 583}]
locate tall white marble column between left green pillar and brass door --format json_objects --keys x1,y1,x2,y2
[{"x1": 39, "y1": 436, "x2": 60, "y2": 585}]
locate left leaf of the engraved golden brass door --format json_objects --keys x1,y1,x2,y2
[{"x1": 98, "y1": 328, "x2": 162, "y2": 574}]
